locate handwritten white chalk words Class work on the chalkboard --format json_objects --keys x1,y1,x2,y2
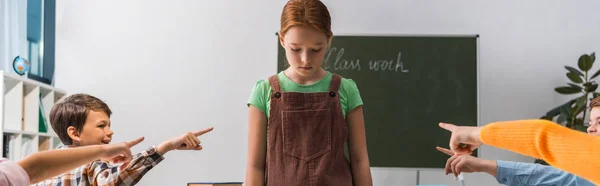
[{"x1": 323, "y1": 47, "x2": 409, "y2": 73}]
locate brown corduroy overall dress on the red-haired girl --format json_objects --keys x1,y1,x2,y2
[{"x1": 266, "y1": 74, "x2": 352, "y2": 186}]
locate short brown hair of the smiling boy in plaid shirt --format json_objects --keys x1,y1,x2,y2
[{"x1": 50, "y1": 94, "x2": 112, "y2": 145}]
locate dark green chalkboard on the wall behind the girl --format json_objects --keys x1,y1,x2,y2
[{"x1": 277, "y1": 35, "x2": 478, "y2": 168}]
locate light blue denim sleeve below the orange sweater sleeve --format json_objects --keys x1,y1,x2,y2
[{"x1": 496, "y1": 160, "x2": 594, "y2": 186}]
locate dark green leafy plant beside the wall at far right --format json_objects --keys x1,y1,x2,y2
[{"x1": 536, "y1": 53, "x2": 600, "y2": 164}]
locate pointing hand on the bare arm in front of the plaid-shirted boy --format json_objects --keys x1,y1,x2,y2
[{"x1": 102, "y1": 137, "x2": 144, "y2": 164}]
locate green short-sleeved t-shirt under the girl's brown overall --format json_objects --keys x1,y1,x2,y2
[{"x1": 248, "y1": 71, "x2": 363, "y2": 118}]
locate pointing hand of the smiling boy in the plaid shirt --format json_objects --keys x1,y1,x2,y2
[{"x1": 156, "y1": 127, "x2": 213, "y2": 155}]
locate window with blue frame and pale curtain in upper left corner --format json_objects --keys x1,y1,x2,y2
[{"x1": 0, "y1": 0, "x2": 56, "y2": 84}]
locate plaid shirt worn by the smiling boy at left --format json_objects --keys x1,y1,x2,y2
[{"x1": 35, "y1": 146, "x2": 164, "y2": 186}]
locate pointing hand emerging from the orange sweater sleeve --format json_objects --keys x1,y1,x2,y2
[{"x1": 440, "y1": 123, "x2": 483, "y2": 155}]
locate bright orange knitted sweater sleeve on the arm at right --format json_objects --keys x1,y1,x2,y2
[{"x1": 480, "y1": 120, "x2": 600, "y2": 185}]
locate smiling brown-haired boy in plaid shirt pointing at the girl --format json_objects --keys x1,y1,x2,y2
[{"x1": 36, "y1": 94, "x2": 213, "y2": 186}]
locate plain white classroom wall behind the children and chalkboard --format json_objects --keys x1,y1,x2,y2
[{"x1": 56, "y1": 0, "x2": 600, "y2": 185}]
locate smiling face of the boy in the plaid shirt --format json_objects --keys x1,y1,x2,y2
[{"x1": 71, "y1": 110, "x2": 113, "y2": 146}]
